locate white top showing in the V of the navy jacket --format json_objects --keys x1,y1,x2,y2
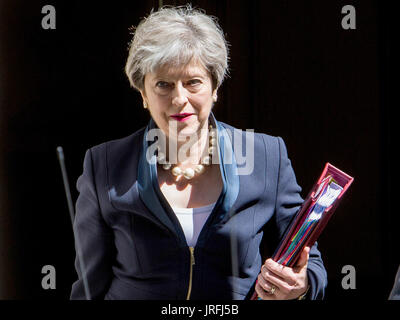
[{"x1": 172, "y1": 202, "x2": 215, "y2": 247}]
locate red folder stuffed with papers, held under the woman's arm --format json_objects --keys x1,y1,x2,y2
[{"x1": 252, "y1": 163, "x2": 354, "y2": 299}]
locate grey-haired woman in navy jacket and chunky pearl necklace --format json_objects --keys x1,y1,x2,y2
[{"x1": 71, "y1": 6, "x2": 326, "y2": 299}]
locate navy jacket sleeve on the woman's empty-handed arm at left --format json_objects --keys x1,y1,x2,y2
[{"x1": 70, "y1": 149, "x2": 113, "y2": 300}]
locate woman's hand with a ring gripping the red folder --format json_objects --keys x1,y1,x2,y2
[{"x1": 255, "y1": 247, "x2": 310, "y2": 300}]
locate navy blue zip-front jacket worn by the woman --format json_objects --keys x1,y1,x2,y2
[{"x1": 71, "y1": 116, "x2": 327, "y2": 300}]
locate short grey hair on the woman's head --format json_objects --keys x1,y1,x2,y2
[{"x1": 125, "y1": 5, "x2": 229, "y2": 91}]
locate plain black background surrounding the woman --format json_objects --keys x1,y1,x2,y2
[{"x1": 0, "y1": 0, "x2": 394, "y2": 300}]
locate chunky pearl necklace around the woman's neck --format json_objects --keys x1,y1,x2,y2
[{"x1": 157, "y1": 125, "x2": 217, "y2": 180}]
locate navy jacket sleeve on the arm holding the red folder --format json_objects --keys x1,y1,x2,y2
[{"x1": 276, "y1": 137, "x2": 327, "y2": 300}]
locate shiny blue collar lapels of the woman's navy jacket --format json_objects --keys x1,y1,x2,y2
[{"x1": 137, "y1": 113, "x2": 239, "y2": 243}]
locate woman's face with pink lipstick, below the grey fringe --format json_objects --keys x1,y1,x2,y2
[{"x1": 141, "y1": 62, "x2": 216, "y2": 138}]
